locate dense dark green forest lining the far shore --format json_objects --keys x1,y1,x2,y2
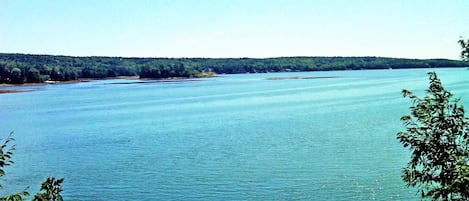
[{"x1": 0, "y1": 53, "x2": 469, "y2": 84}]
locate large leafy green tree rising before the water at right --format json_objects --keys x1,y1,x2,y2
[{"x1": 397, "y1": 72, "x2": 469, "y2": 200}]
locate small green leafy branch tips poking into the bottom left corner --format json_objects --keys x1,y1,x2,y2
[{"x1": 0, "y1": 132, "x2": 64, "y2": 201}]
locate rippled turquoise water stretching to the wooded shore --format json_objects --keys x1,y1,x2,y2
[{"x1": 0, "y1": 68, "x2": 469, "y2": 200}]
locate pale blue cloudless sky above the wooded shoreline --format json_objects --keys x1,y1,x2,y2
[{"x1": 0, "y1": 0, "x2": 469, "y2": 59}]
